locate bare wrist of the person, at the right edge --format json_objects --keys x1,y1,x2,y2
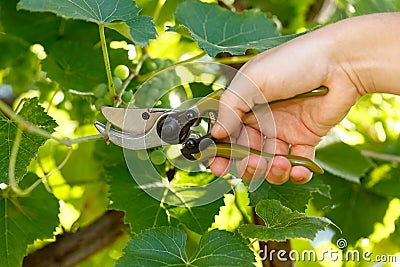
[{"x1": 326, "y1": 13, "x2": 400, "y2": 96}]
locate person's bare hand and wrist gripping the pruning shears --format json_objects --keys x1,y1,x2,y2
[{"x1": 211, "y1": 13, "x2": 400, "y2": 184}]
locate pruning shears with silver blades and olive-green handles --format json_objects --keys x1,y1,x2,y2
[{"x1": 95, "y1": 86, "x2": 328, "y2": 173}]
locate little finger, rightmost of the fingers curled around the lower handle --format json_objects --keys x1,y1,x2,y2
[{"x1": 290, "y1": 145, "x2": 315, "y2": 184}]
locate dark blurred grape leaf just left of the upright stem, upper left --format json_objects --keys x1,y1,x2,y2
[{"x1": 43, "y1": 41, "x2": 106, "y2": 92}]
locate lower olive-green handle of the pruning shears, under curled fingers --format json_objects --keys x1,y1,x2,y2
[{"x1": 193, "y1": 143, "x2": 324, "y2": 174}]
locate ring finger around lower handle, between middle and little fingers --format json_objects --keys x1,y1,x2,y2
[{"x1": 264, "y1": 139, "x2": 292, "y2": 184}]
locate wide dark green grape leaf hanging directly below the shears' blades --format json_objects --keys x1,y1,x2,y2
[{"x1": 103, "y1": 146, "x2": 222, "y2": 234}]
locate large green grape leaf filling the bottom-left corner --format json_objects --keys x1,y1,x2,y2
[{"x1": 0, "y1": 173, "x2": 58, "y2": 267}]
